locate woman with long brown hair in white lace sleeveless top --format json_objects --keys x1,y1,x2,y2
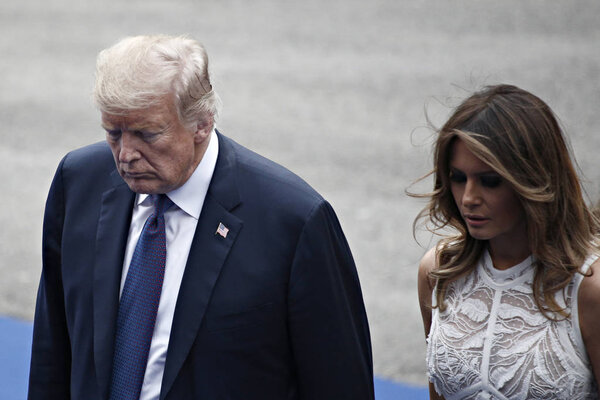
[{"x1": 417, "y1": 85, "x2": 600, "y2": 400}]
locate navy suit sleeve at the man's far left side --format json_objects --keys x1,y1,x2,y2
[{"x1": 28, "y1": 159, "x2": 71, "y2": 400}]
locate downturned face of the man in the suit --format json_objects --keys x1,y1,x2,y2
[{"x1": 102, "y1": 96, "x2": 210, "y2": 194}]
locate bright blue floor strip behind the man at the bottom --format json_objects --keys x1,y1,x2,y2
[{"x1": 0, "y1": 317, "x2": 429, "y2": 400}]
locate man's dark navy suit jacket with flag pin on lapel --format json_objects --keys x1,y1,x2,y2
[{"x1": 29, "y1": 134, "x2": 374, "y2": 400}]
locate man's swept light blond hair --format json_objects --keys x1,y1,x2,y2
[{"x1": 94, "y1": 35, "x2": 221, "y2": 129}]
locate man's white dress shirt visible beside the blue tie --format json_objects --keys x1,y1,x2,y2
[{"x1": 121, "y1": 130, "x2": 219, "y2": 400}]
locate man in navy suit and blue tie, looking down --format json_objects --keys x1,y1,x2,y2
[{"x1": 29, "y1": 36, "x2": 373, "y2": 400}]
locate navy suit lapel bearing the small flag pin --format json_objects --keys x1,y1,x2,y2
[{"x1": 160, "y1": 134, "x2": 243, "y2": 399}]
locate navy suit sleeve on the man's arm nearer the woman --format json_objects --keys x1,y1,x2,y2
[{"x1": 288, "y1": 201, "x2": 374, "y2": 400}]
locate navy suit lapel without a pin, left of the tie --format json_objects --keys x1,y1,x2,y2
[{"x1": 93, "y1": 171, "x2": 135, "y2": 399}]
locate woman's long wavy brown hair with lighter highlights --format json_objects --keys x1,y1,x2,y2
[{"x1": 415, "y1": 85, "x2": 598, "y2": 319}]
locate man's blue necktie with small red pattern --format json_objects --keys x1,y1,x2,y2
[{"x1": 110, "y1": 194, "x2": 173, "y2": 400}]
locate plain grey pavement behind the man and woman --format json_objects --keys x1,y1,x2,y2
[{"x1": 0, "y1": 0, "x2": 600, "y2": 384}]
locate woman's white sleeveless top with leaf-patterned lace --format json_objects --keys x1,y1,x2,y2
[{"x1": 427, "y1": 251, "x2": 598, "y2": 400}]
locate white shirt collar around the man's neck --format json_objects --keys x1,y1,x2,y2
[{"x1": 136, "y1": 129, "x2": 219, "y2": 219}]
